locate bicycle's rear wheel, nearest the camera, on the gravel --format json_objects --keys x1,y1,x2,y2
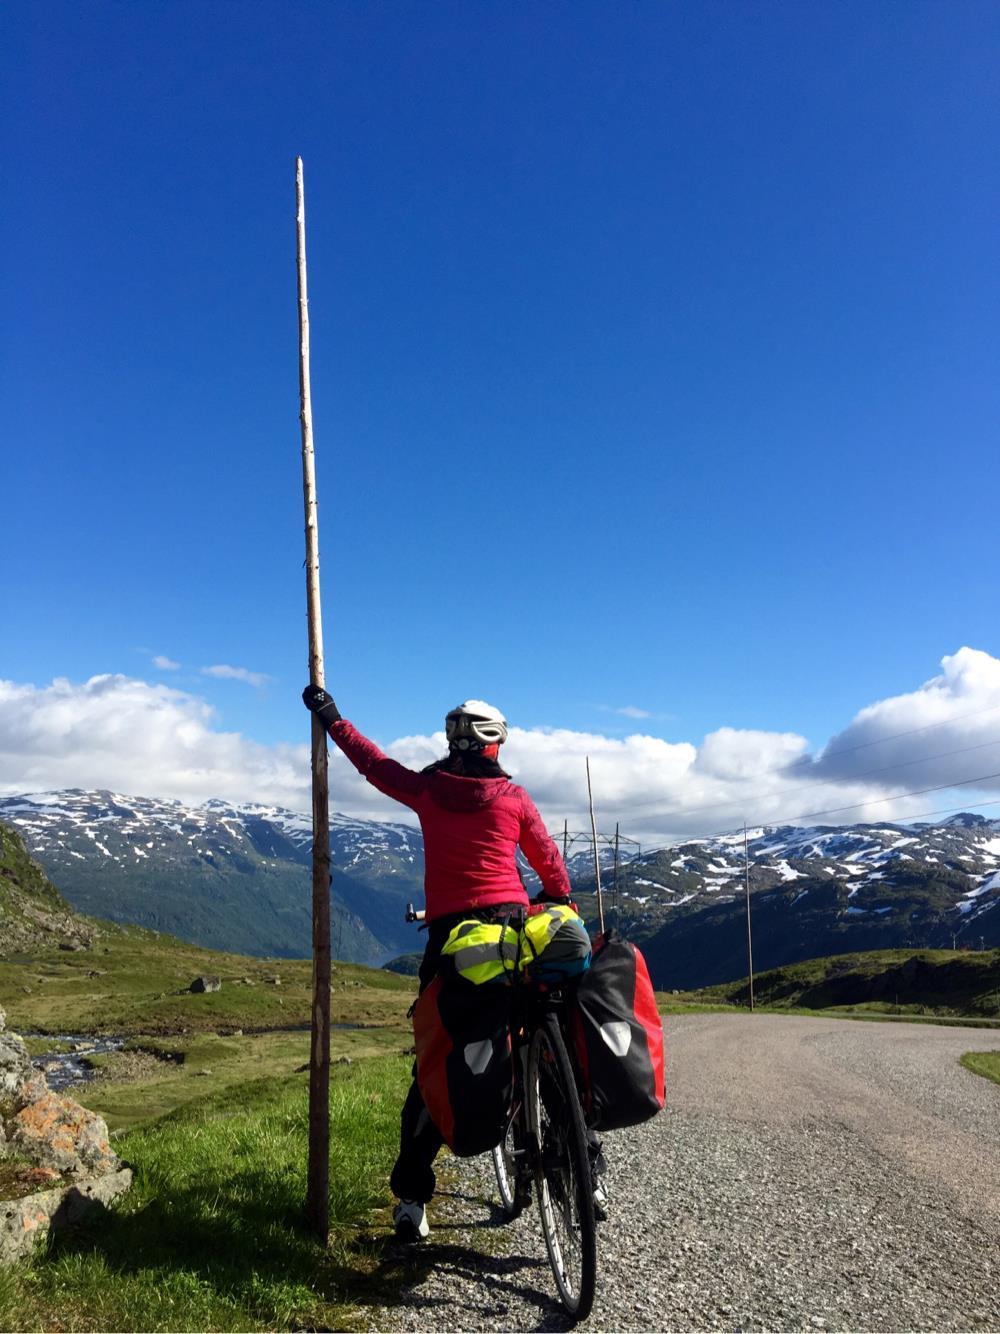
[{"x1": 527, "y1": 1014, "x2": 597, "y2": 1321}]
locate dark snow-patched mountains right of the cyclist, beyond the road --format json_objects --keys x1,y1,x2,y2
[{"x1": 580, "y1": 815, "x2": 1000, "y2": 987}]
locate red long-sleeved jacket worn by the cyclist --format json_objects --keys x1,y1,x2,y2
[{"x1": 329, "y1": 719, "x2": 569, "y2": 920}]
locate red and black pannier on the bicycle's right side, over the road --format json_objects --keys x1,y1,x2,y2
[{"x1": 572, "y1": 930, "x2": 665, "y2": 1130}]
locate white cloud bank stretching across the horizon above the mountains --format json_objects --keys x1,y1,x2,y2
[{"x1": 0, "y1": 648, "x2": 1000, "y2": 842}]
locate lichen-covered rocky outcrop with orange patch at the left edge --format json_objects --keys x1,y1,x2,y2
[{"x1": 0, "y1": 1009, "x2": 132, "y2": 1263}]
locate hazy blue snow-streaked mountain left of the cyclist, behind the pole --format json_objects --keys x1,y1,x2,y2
[{"x1": 0, "y1": 790, "x2": 423, "y2": 962}]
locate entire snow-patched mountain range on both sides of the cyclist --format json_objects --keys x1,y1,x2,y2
[{"x1": 0, "y1": 790, "x2": 1000, "y2": 986}]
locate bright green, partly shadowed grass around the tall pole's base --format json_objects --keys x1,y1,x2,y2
[{"x1": 0, "y1": 1055, "x2": 440, "y2": 1331}]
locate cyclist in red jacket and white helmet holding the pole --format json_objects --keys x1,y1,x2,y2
[{"x1": 303, "y1": 686, "x2": 569, "y2": 1241}]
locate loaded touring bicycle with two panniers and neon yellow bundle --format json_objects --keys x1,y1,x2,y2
[{"x1": 407, "y1": 903, "x2": 664, "y2": 1319}]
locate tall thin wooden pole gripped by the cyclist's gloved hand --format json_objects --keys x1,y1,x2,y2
[{"x1": 295, "y1": 157, "x2": 329, "y2": 1245}]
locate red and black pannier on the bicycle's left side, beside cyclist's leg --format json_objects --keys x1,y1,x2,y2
[{"x1": 413, "y1": 971, "x2": 513, "y2": 1158}]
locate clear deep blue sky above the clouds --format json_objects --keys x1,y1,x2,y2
[{"x1": 0, "y1": 0, "x2": 1000, "y2": 832}]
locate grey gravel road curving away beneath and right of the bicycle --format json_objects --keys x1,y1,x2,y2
[{"x1": 367, "y1": 1015, "x2": 1000, "y2": 1331}]
